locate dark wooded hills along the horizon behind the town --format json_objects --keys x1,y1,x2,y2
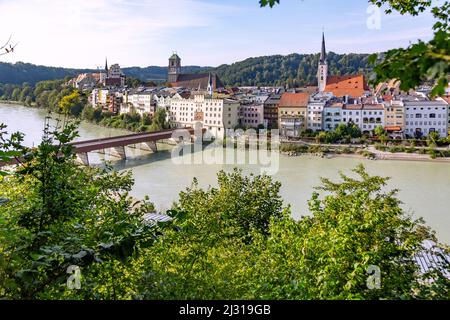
[{"x1": 0, "y1": 52, "x2": 370, "y2": 87}]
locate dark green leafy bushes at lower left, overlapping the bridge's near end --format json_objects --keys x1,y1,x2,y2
[{"x1": 0, "y1": 120, "x2": 157, "y2": 299}]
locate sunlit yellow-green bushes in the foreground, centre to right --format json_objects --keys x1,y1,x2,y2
[{"x1": 140, "y1": 166, "x2": 449, "y2": 299}]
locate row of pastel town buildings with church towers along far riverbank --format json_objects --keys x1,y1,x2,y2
[{"x1": 81, "y1": 35, "x2": 450, "y2": 138}]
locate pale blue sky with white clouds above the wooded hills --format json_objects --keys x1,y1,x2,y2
[{"x1": 0, "y1": 0, "x2": 433, "y2": 68}]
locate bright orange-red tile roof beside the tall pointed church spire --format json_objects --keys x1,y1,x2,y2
[{"x1": 325, "y1": 75, "x2": 370, "y2": 98}]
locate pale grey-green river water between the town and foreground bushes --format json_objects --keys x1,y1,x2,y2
[{"x1": 0, "y1": 104, "x2": 450, "y2": 244}]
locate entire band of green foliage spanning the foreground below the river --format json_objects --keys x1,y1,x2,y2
[{"x1": 0, "y1": 124, "x2": 450, "y2": 299}]
